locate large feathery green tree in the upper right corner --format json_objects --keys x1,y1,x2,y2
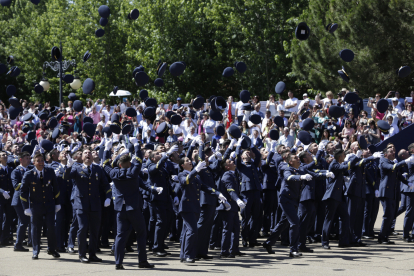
[{"x1": 290, "y1": 0, "x2": 414, "y2": 96}]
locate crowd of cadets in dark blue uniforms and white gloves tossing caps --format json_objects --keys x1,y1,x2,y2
[{"x1": 0, "y1": 129, "x2": 414, "y2": 269}]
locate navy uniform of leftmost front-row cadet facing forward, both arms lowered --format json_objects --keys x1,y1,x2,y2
[{"x1": 20, "y1": 167, "x2": 60, "y2": 255}]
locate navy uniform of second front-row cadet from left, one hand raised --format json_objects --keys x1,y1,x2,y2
[{"x1": 70, "y1": 164, "x2": 112, "y2": 257}]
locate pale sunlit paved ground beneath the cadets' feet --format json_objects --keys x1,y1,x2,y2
[{"x1": 0, "y1": 209, "x2": 414, "y2": 276}]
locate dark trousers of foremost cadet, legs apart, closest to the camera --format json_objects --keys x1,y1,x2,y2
[{"x1": 115, "y1": 205, "x2": 147, "y2": 265}]
